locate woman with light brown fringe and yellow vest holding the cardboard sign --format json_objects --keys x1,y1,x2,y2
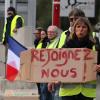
[{"x1": 59, "y1": 17, "x2": 96, "y2": 100}]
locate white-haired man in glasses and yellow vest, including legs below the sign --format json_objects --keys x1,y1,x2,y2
[{"x1": 46, "y1": 25, "x2": 61, "y2": 100}]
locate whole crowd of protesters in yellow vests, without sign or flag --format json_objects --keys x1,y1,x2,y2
[{"x1": 2, "y1": 7, "x2": 100, "y2": 100}]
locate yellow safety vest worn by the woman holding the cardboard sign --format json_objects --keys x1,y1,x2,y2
[{"x1": 59, "y1": 32, "x2": 96, "y2": 98}]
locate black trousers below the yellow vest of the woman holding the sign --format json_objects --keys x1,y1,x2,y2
[{"x1": 61, "y1": 94, "x2": 93, "y2": 100}]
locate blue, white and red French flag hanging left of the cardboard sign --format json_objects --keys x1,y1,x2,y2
[{"x1": 6, "y1": 36, "x2": 27, "y2": 81}]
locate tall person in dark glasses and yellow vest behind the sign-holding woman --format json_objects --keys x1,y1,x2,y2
[{"x1": 58, "y1": 8, "x2": 85, "y2": 48}]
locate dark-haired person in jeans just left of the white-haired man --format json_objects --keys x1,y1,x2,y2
[{"x1": 36, "y1": 29, "x2": 52, "y2": 100}]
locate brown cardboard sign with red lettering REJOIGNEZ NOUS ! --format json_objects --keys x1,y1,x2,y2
[{"x1": 17, "y1": 48, "x2": 97, "y2": 83}]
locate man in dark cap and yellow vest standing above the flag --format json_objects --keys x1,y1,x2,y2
[{"x1": 2, "y1": 7, "x2": 24, "y2": 45}]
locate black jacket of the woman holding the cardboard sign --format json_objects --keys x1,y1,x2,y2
[{"x1": 63, "y1": 35, "x2": 100, "y2": 64}]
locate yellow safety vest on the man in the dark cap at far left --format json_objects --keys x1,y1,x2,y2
[{"x1": 2, "y1": 15, "x2": 24, "y2": 42}]
